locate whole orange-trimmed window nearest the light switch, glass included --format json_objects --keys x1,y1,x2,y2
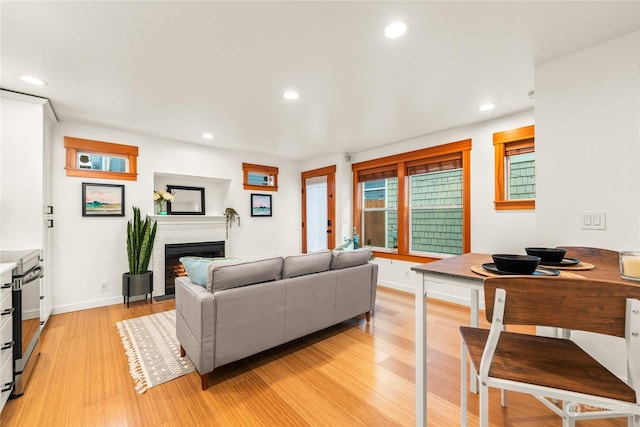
[{"x1": 493, "y1": 125, "x2": 536, "y2": 210}]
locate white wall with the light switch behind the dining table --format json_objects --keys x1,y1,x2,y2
[{"x1": 536, "y1": 32, "x2": 640, "y2": 250}]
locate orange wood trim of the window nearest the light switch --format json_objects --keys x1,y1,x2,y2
[{"x1": 493, "y1": 125, "x2": 536, "y2": 210}]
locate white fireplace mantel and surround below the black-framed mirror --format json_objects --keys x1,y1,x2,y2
[{"x1": 149, "y1": 215, "x2": 230, "y2": 296}]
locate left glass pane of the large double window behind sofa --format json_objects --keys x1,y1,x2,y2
[{"x1": 362, "y1": 178, "x2": 398, "y2": 249}]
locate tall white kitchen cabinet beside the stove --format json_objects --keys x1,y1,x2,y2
[{"x1": 0, "y1": 90, "x2": 57, "y2": 324}]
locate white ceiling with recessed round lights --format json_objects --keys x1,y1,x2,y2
[{"x1": 0, "y1": 1, "x2": 640, "y2": 160}]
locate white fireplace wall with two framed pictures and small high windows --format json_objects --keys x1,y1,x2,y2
[{"x1": 52, "y1": 122, "x2": 301, "y2": 313}]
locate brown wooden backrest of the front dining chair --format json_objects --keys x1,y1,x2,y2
[{"x1": 484, "y1": 276, "x2": 640, "y2": 338}]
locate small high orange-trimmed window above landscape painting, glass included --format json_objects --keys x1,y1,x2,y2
[{"x1": 64, "y1": 136, "x2": 138, "y2": 181}]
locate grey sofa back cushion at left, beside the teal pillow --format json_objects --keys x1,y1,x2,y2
[{"x1": 207, "y1": 257, "x2": 282, "y2": 292}]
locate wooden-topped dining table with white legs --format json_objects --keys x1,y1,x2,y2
[{"x1": 411, "y1": 250, "x2": 640, "y2": 426}]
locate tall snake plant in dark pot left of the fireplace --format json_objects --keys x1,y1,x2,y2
[{"x1": 122, "y1": 206, "x2": 158, "y2": 307}]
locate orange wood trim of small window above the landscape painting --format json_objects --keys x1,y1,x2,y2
[{"x1": 64, "y1": 136, "x2": 138, "y2": 181}]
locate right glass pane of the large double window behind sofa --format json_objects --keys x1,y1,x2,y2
[{"x1": 410, "y1": 169, "x2": 463, "y2": 255}]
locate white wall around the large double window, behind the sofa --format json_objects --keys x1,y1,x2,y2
[{"x1": 349, "y1": 110, "x2": 538, "y2": 303}]
